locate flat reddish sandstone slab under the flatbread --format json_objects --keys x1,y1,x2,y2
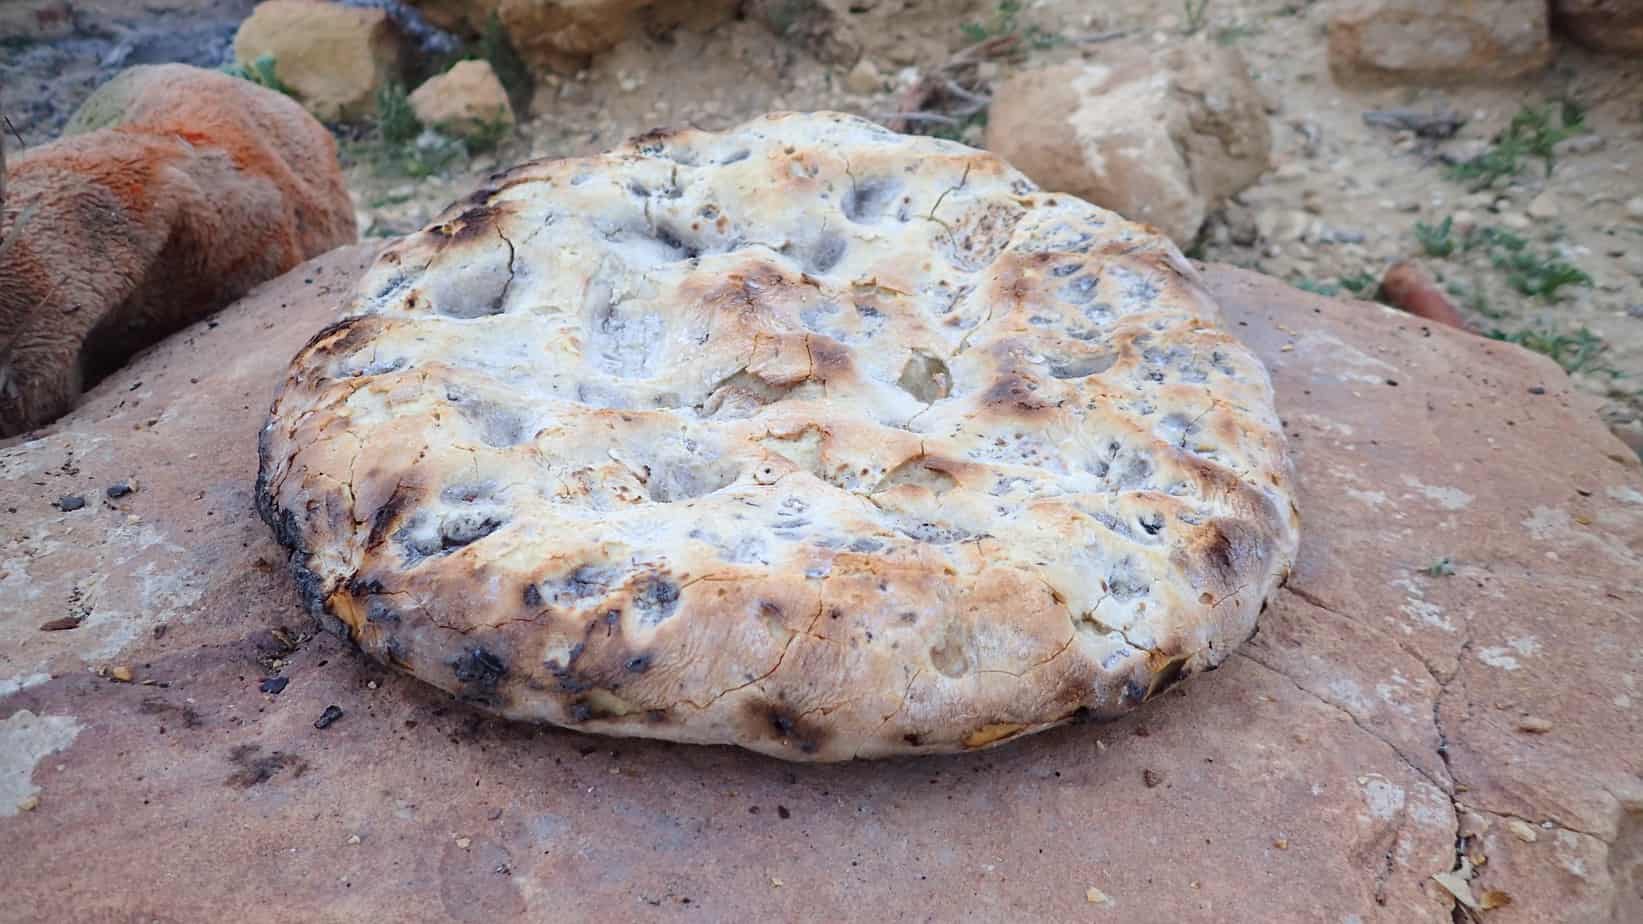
[{"x1": 0, "y1": 247, "x2": 1643, "y2": 924}]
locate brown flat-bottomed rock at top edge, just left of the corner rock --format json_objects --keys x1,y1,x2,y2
[{"x1": 1329, "y1": 0, "x2": 1551, "y2": 84}]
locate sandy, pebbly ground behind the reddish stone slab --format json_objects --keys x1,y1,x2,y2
[{"x1": 0, "y1": 0, "x2": 1643, "y2": 450}]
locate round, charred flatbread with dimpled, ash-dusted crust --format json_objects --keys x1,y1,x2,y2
[{"x1": 258, "y1": 113, "x2": 1296, "y2": 760}]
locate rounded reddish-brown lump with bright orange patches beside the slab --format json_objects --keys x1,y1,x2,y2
[{"x1": 0, "y1": 64, "x2": 355, "y2": 437}]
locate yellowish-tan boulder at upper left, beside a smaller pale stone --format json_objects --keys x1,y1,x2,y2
[{"x1": 233, "y1": 0, "x2": 403, "y2": 122}]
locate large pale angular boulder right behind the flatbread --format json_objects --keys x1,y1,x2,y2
[{"x1": 986, "y1": 43, "x2": 1272, "y2": 247}]
